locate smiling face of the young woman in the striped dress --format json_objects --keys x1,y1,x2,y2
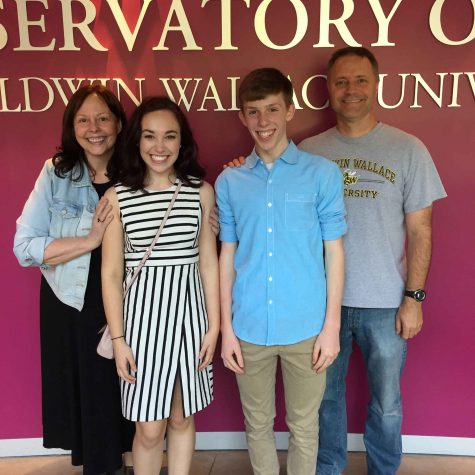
[{"x1": 139, "y1": 109, "x2": 181, "y2": 187}]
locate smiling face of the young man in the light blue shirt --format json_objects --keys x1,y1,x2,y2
[{"x1": 239, "y1": 93, "x2": 295, "y2": 163}]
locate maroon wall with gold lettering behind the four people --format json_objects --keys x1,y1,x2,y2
[{"x1": 0, "y1": 0, "x2": 475, "y2": 439}]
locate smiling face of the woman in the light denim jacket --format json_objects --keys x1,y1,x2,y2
[{"x1": 74, "y1": 94, "x2": 122, "y2": 164}]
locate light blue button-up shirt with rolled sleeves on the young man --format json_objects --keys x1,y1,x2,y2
[{"x1": 216, "y1": 142, "x2": 346, "y2": 345}]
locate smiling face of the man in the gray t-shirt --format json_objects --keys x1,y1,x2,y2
[{"x1": 328, "y1": 55, "x2": 378, "y2": 127}]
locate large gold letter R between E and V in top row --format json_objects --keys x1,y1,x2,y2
[{"x1": 59, "y1": 0, "x2": 109, "y2": 51}]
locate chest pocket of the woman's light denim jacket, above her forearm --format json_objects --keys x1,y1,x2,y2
[{"x1": 49, "y1": 201, "x2": 93, "y2": 238}]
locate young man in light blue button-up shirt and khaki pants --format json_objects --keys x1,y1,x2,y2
[{"x1": 216, "y1": 68, "x2": 346, "y2": 475}]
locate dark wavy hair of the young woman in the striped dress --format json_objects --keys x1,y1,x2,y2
[{"x1": 119, "y1": 96, "x2": 205, "y2": 191}]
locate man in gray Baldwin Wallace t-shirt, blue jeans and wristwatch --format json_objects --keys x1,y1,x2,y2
[{"x1": 300, "y1": 47, "x2": 446, "y2": 475}]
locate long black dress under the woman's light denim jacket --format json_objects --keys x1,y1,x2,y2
[{"x1": 40, "y1": 183, "x2": 134, "y2": 475}]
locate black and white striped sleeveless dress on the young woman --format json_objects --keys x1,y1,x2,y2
[{"x1": 115, "y1": 180, "x2": 213, "y2": 422}]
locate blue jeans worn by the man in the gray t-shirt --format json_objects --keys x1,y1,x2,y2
[{"x1": 317, "y1": 307, "x2": 406, "y2": 475}]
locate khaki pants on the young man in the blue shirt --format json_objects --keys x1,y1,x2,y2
[{"x1": 237, "y1": 337, "x2": 325, "y2": 475}]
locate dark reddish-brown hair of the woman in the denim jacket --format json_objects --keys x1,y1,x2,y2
[{"x1": 53, "y1": 84, "x2": 127, "y2": 183}]
